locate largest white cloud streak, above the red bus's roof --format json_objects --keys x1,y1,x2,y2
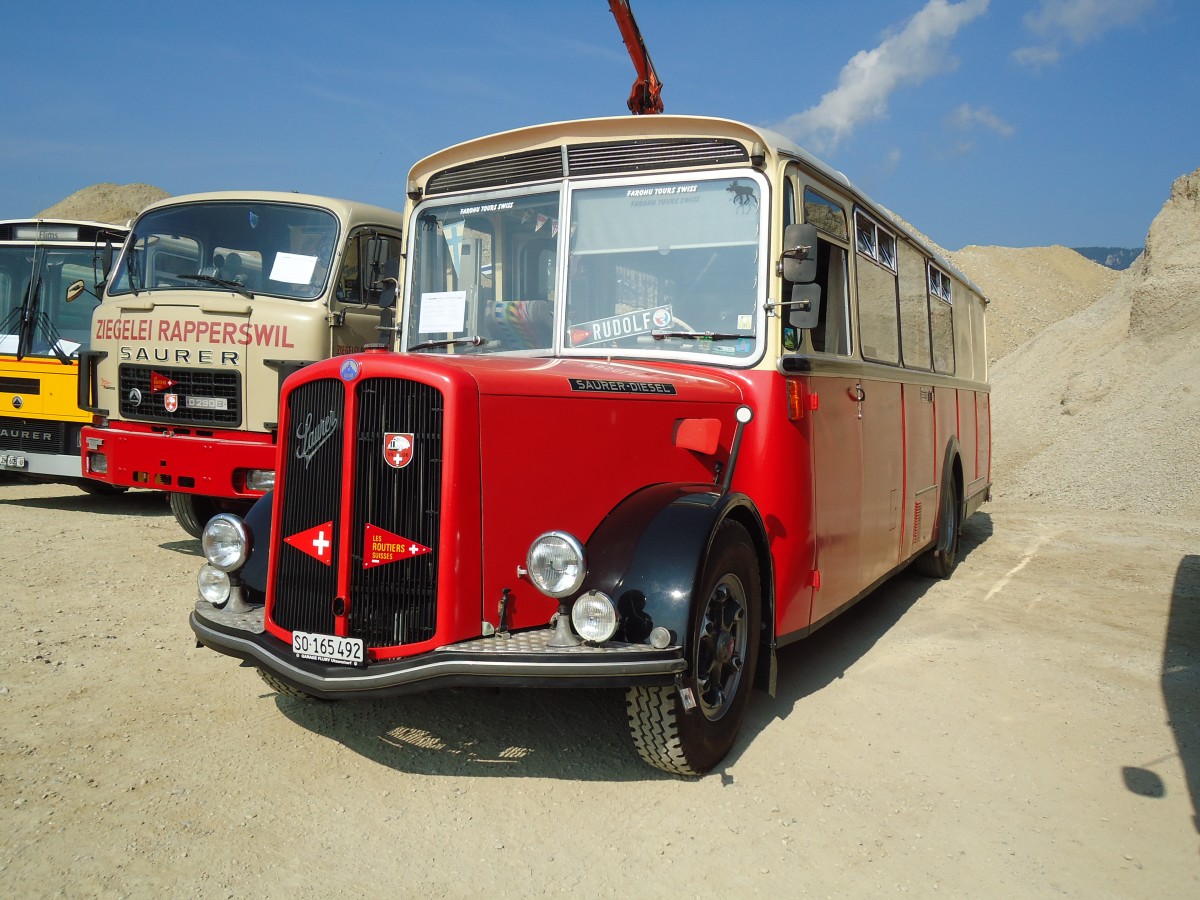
[{"x1": 772, "y1": 0, "x2": 989, "y2": 152}]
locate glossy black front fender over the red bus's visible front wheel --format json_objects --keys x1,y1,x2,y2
[{"x1": 582, "y1": 484, "x2": 766, "y2": 643}]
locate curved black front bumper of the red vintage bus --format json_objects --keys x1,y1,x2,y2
[{"x1": 190, "y1": 600, "x2": 686, "y2": 700}]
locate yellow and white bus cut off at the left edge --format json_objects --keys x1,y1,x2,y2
[{"x1": 0, "y1": 218, "x2": 126, "y2": 492}]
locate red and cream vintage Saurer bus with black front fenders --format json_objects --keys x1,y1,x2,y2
[{"x1": 191, "y1": 115, "x2": 991, "y2": 774}]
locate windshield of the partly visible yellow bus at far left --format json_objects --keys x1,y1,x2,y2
[{"x1": 0, "y1": 245, "x2": 108, "y2": 358}]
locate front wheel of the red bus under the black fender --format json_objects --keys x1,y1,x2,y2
[{"x1": 625, "y1": 521, "x2": 762, "y2": 775}]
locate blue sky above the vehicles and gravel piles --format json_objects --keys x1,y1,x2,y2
[{"x1": 0, "y1": 0, "x2": 1200, "y2": 250}]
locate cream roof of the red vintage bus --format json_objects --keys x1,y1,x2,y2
[{"x1": 408, "y1": 115, "x2": 983, "y2": 298}]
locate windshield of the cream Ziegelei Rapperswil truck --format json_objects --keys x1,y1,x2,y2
[{"x1": 108, "y1": 202, "x2": 338, "y2": 300}]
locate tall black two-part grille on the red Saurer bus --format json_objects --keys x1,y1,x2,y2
[{"x1": 271, "y1": 378, "x2": 443, "y2": 647}]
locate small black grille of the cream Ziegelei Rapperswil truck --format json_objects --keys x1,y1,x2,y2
[{"x1": 118, "y1": 366, "x2": 241, "y2": 427}]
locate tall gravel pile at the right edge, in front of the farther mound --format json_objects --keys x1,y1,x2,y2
[{"x1": 984, "y1": 169, "x2": 1200, "y2": 518}]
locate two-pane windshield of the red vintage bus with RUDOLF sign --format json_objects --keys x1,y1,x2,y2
[{"x1": 407, "y1": 174, "x2": 766, "y2": 361}]
